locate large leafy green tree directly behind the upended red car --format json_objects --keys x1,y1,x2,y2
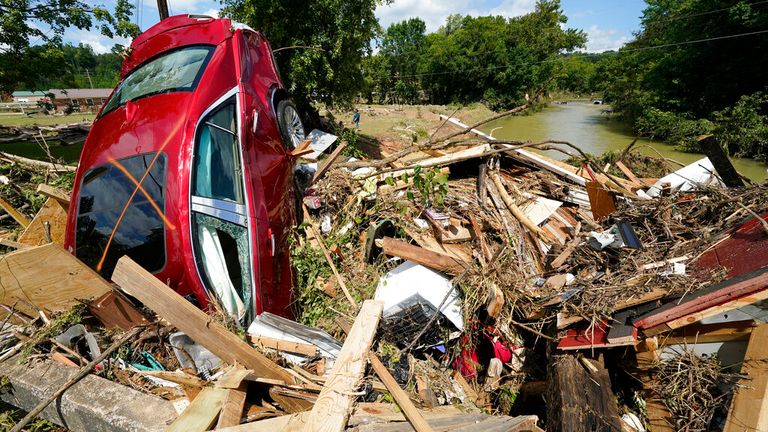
[{"x1": 222, "y1": 0, "x2": 390, "y2": 108}]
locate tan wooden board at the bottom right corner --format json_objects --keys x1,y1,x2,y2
[{"x1": 723, "y1": 324, "x2": 768, "y2": 432}]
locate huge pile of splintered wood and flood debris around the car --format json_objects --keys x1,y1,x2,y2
[{"x1": 0, "y1": 106, "x2": 768, "y2": 431}]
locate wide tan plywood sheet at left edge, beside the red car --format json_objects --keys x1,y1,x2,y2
[{"x1": 0, "y1": 244, "x2": 112, "y2": 317}]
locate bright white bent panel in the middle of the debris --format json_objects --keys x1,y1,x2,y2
[{"x1": 374, "y1": 261, "x2": 464, "y2": 330}]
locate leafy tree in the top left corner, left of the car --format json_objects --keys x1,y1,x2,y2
[{"x1": 0, "y1": 0, "x2": 139, "y2": 93}]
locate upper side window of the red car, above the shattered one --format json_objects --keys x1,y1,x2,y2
[{"x1": 192, "y1": 99, "x2": 244, "y2": 204}]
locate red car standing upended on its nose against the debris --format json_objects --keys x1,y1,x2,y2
[{"x1": 66, "y1": 15, "x2": 304, "y2": 325}]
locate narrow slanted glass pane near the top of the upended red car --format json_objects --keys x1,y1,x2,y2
[{"x1": 102, "y1": 46, "x2": 213, "y2": 115}]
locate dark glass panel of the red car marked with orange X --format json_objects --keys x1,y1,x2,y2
[{"x1": 75, "y1": 153, "x2": 167, "y2": 278}]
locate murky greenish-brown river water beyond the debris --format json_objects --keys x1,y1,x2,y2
[{"x1": 481, "y1": 102, "x2": 768, "y2": 182}]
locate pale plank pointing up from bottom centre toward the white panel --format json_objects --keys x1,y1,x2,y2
[{"x1": 304, "y1": 300, "x2": 384, "y2": 432}]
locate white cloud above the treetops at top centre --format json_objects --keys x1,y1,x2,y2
[{"x1": 376, "y1": 0, "x2": 536, "y2": 33}]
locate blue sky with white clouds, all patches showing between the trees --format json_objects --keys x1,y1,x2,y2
[{"x1": 58, "y1": 0, "x2": 645, "y2": 53}]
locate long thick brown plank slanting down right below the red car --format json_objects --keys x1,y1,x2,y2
[{"x1": 112, "y1": 256, "x2": 310, "y2": 411}]
